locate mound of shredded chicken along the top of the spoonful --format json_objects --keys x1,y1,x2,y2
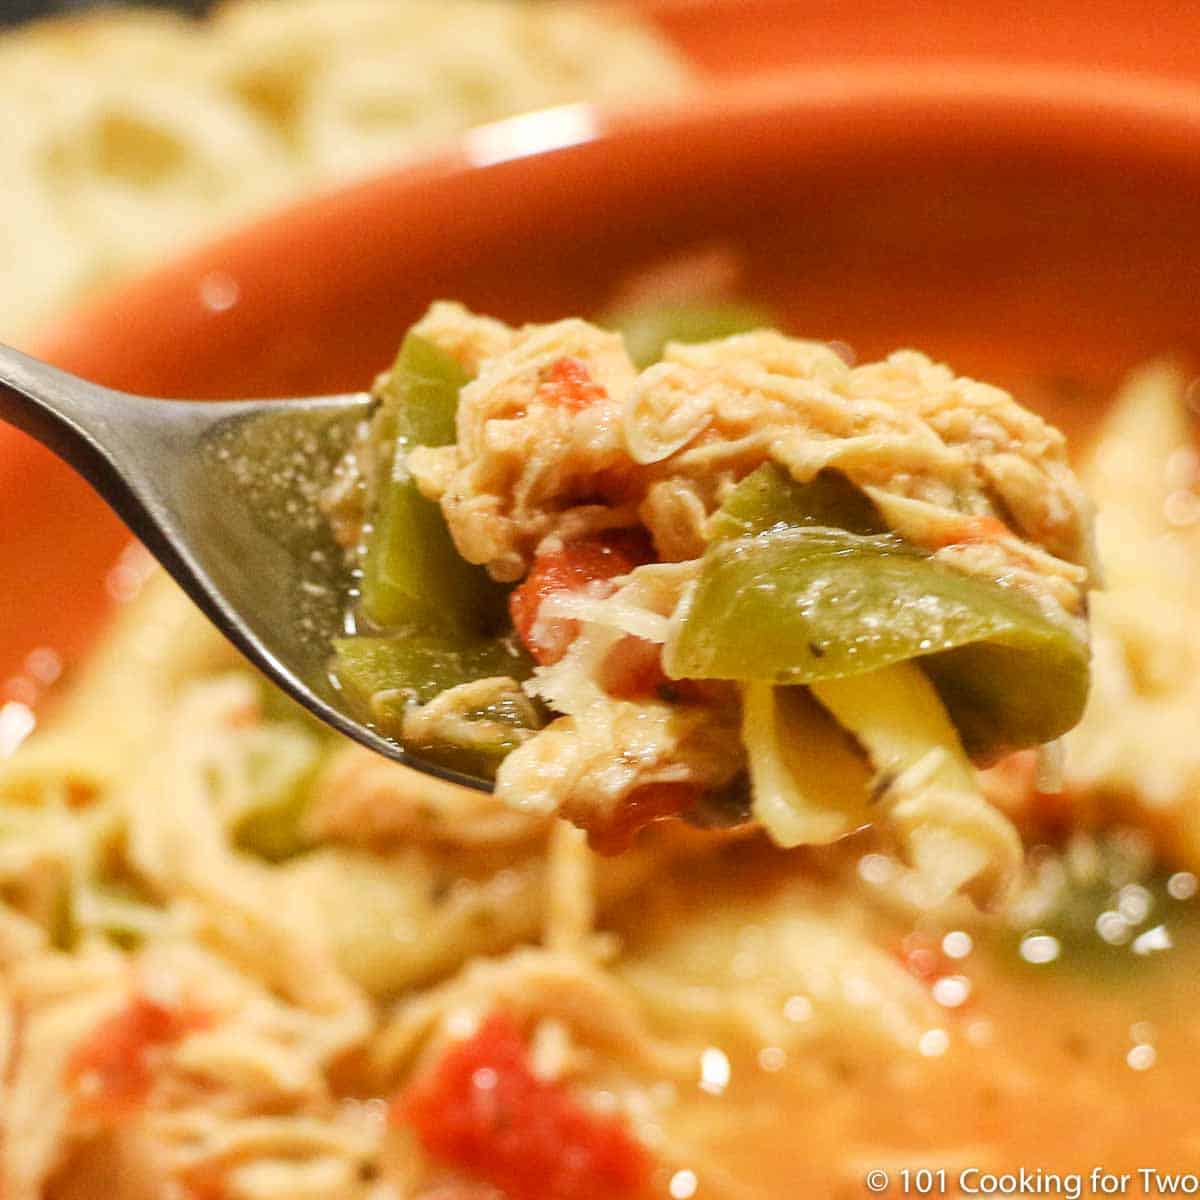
[{"x1": 409, "y1": 304, "x2": 1094, "y2": 613}]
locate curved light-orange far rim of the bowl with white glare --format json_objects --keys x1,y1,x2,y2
[{"x1": 25, "y1": 60, "x2": 1200, "y2": 364}]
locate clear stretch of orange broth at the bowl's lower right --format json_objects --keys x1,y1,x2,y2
[{"x1": 638, "y1": 859, "x2": 1200, "y2": 1200}]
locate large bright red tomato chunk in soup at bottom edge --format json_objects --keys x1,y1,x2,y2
[{"x1": 391, "y1": 1013, "x2": 652, "y2": 1200}]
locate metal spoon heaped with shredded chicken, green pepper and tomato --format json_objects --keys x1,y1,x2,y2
[{"x1": 0, "y1": 302, "x2": 1093, "y2": 894}]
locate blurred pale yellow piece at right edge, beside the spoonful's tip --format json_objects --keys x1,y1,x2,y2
[{"x1": 1066, "y1": 362, "x2": 1200, "y2": 866}]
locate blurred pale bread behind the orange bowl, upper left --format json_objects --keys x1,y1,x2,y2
[{"x1": 0, "y1": 0, "x2": 690, "y2": 342}]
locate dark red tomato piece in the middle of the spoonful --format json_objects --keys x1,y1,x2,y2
[{"x1": 509, "y1": 530, "x2": 652, "y2": 666}]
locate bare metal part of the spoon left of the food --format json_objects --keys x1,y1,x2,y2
[{"x1": 0, "y1": 346, "x2": 492, "y2": 791}]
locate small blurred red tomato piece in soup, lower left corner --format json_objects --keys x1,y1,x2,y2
[{"x1": 67, "y1": 996, "x2": 209, "y2": 1121}]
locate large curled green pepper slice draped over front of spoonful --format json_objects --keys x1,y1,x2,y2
[{"x1": 664, "y1": 526, "x2": 1088, "y2": 757}]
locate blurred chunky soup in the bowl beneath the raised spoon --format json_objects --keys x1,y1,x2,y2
[{"x1": 0, "y1": 316, "x2": 1200, "y2": 1200}]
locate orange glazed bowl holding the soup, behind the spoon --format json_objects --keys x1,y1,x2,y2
[{"x1": 7, "y1": 67, "x2": 1200, "y2": 701}]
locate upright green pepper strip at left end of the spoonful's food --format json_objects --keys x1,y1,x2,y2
[{"x1": 361, "y1": 334, "x2": 504, "y2": 635}]
